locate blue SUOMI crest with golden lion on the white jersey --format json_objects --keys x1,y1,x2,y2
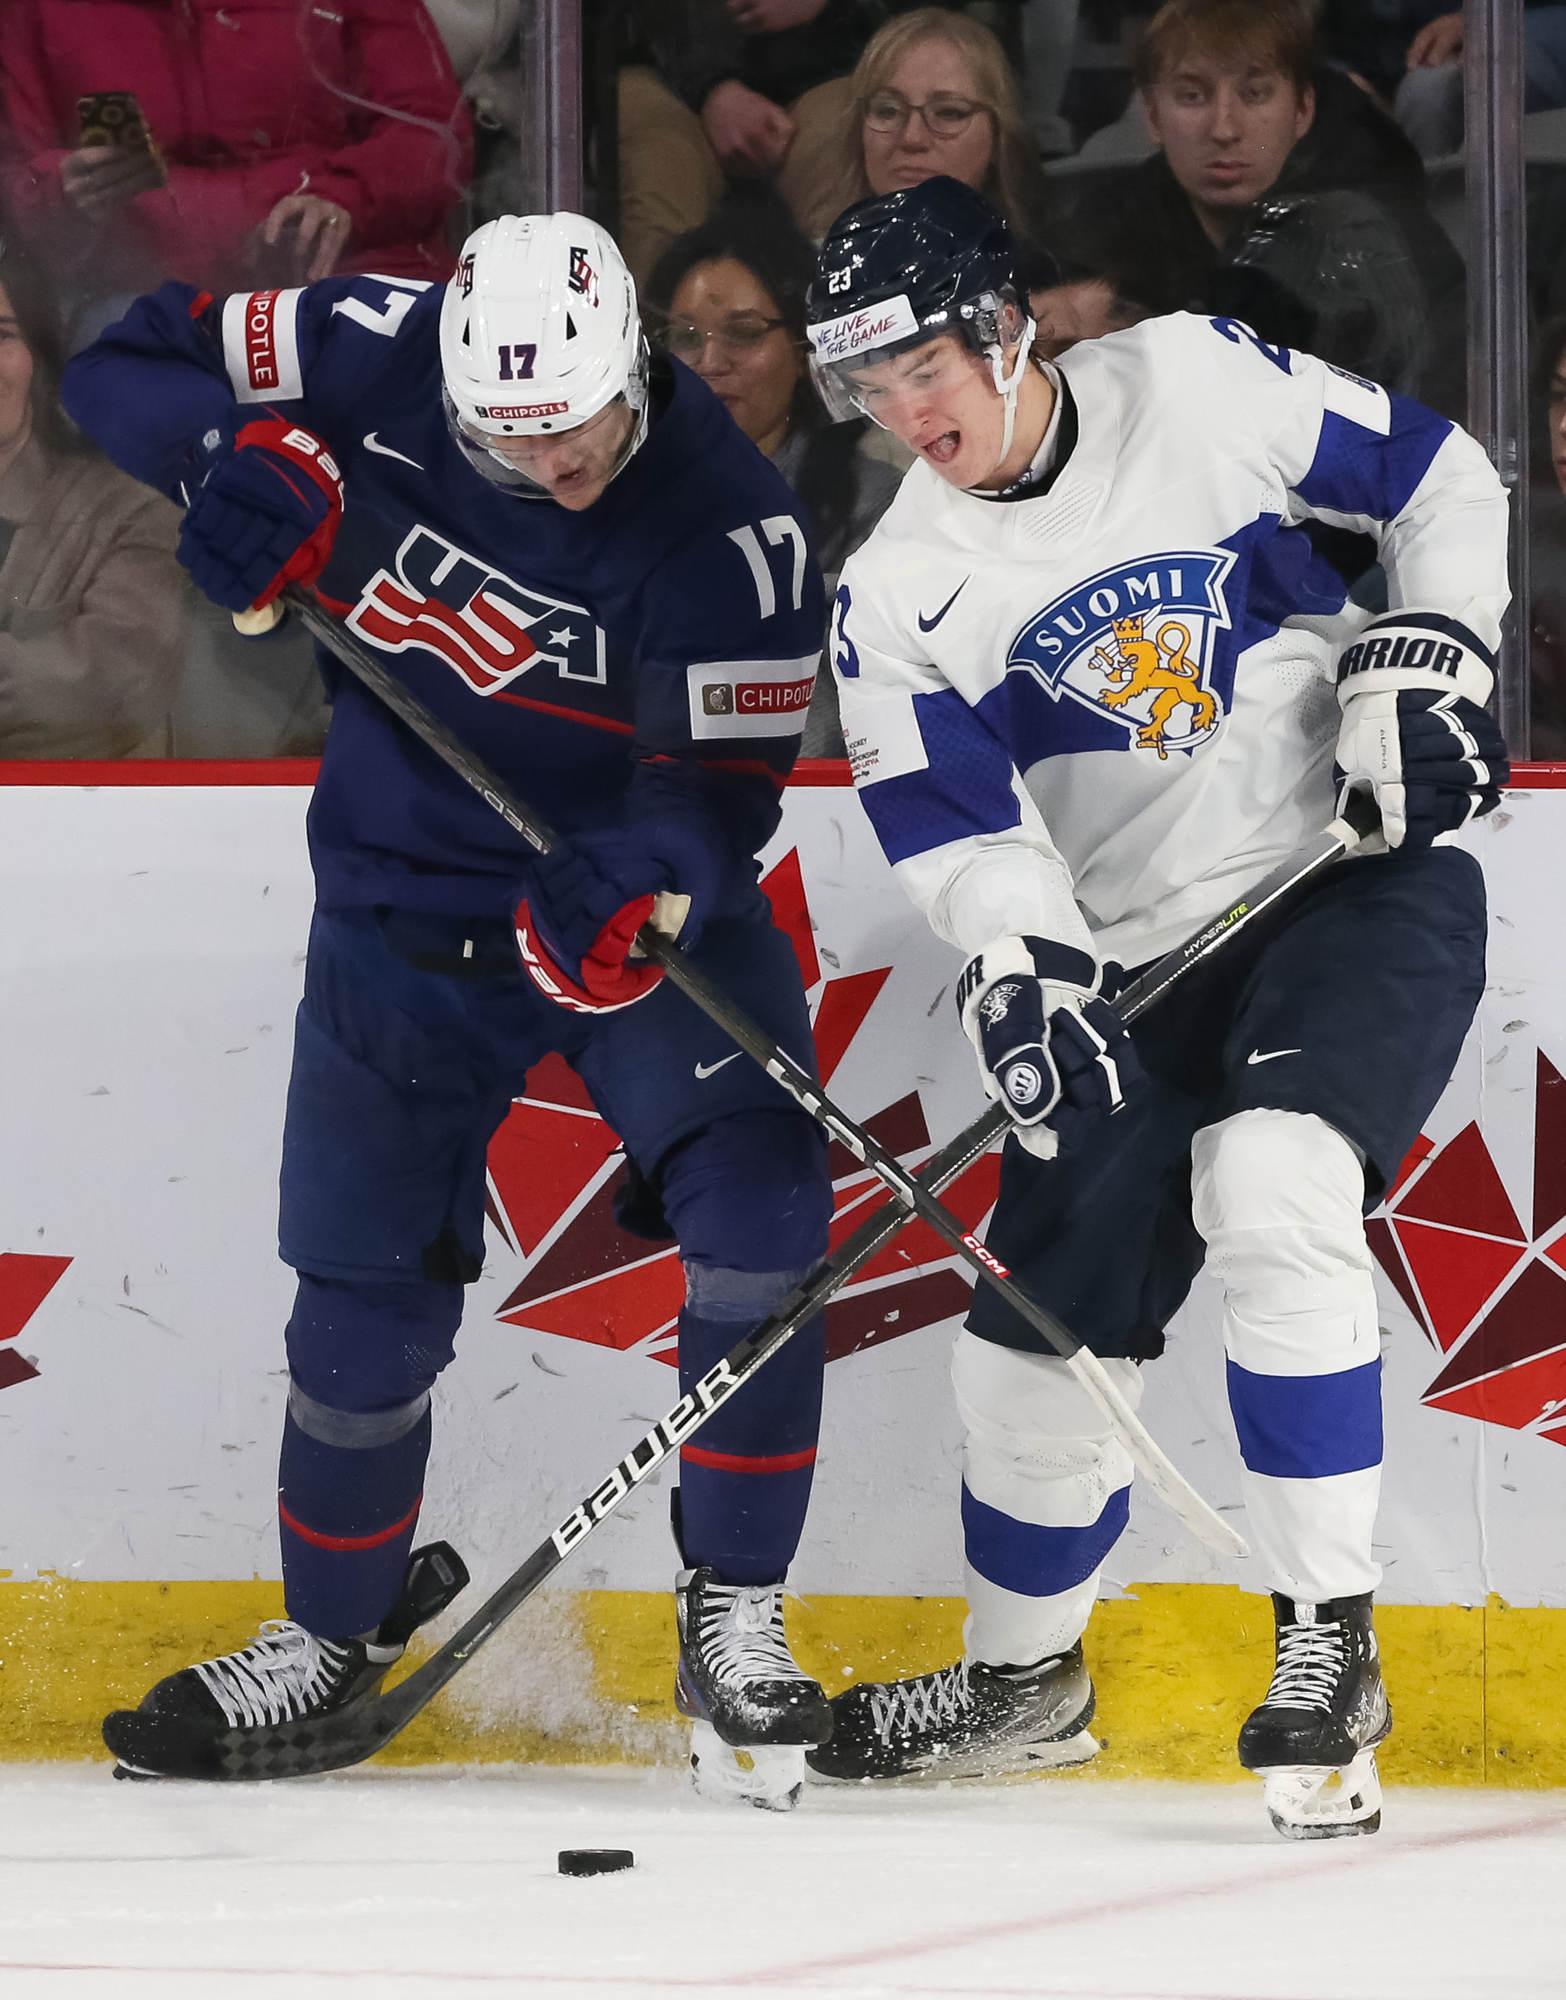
[{"x1": 1006, "y1": 548, "x2": 1234, "y2": 758}]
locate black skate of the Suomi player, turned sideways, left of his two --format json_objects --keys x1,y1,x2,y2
[{"x1": 808, "y1": 1642, "x2": 1098, "y2": 1778}]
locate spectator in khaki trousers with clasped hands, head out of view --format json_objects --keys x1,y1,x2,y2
[{"x1": 620, "y1": 0, "x2": 888, "y2": 286}]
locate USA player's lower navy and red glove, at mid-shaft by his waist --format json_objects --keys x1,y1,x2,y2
[{"x1": 516, "y1": 816, "x2": 720, "y2": 1014}]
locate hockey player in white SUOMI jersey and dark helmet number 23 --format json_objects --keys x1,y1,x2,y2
[{"x1": 810, "y1": 180, "x2": 1508, "y2": 1838}]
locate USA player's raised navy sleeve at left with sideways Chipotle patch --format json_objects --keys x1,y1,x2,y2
[{"x1": 60, "y1": 278, "x2": 428, "y2": 504}]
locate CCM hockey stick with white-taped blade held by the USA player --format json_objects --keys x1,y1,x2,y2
[{"x1": 258, "y1": 586, "x2": 1248, "y2": 1556}]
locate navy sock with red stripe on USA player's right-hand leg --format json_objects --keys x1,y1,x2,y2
[{"x1": 680, "y1": 1286, "x2": 826, "y2": 1584}]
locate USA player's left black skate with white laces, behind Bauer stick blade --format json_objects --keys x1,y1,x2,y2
[{"x1": 104, "y1": 1542, "x2": 468, "y2": 1782}]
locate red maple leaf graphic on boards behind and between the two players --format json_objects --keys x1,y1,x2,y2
[{"x1": 488, "y1": 852, "x2": 1000, "y2": 1362}]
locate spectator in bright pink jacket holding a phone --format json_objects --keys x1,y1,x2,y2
[{"x1": 0, "y1": 0, "x2": 470, "y2": 328}]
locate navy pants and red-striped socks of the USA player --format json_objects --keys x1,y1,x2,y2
[{"x1": 278, "y1": 910, "x2": 832, "y2": 1636}]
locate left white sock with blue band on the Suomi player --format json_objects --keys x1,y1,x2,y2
[{"x1": 952, "y1": 1330, "x2": 1142, "y2": 1666}]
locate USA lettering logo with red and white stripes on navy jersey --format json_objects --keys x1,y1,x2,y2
[{"x1": 348, "y1": 528, "x2": 606, "y2": 694}]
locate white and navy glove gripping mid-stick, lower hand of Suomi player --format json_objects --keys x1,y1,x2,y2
[{"x1": 956, "y1": 938, "x2": 1142, "y2": 1160}]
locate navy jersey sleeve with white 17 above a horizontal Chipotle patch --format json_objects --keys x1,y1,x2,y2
[{"x1": 636, "y1": 498, "x2": 826, "y2": 856}]
